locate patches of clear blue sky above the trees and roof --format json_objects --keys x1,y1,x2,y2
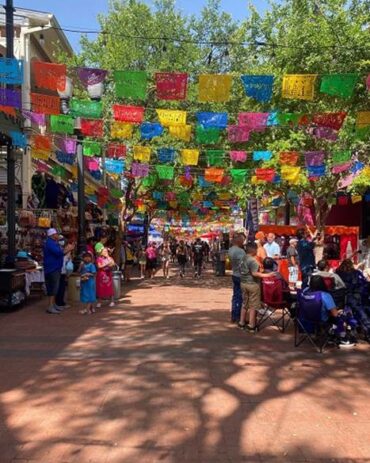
[{"x1": 14, "y1": 0, "x2": 267, "y2": 51}]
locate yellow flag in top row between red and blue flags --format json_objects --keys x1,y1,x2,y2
[{"x1": 198, "y1": 74, "x2": 233, "y2": 102}]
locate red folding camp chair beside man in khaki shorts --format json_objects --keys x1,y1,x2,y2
[{"x1": 257, "y1": 277, "x2": 290, "y2": 333}]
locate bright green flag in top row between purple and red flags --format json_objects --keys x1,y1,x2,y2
[{"x1": 113, "y1": 71, "x2": 148, "y2": 100}]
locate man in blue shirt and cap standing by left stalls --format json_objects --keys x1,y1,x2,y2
[{"x1": 44, "y1": 228, "x2": 73, "y2": 314}]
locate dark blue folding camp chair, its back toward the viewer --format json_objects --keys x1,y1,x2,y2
[{"x1": 294, "y1": 291, "x2": 330, "y2": 354}]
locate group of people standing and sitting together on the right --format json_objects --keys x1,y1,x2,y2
[{"x1": 229, "y1": 229, "x2": 370, "y2": 347}]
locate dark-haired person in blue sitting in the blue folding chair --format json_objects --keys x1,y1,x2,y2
[{"x1": 305, "y1": 275, "x2": 357, "y2": 347}]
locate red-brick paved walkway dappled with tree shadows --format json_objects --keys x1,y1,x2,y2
[{"x1": 0, "y1": 268, "x2": 370, "y2": 463}]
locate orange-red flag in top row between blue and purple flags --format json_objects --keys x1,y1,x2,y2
[{"x1": 31, "y1": 61, "x2": 67, "y2": 91}]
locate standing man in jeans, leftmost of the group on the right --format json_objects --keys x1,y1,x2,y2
[{"x1": 228, "y1": 232, "x2": 246, "y2": 323}]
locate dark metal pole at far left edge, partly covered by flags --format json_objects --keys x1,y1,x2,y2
[{"x1": 4, "y1": 0, "x2": 16, "y2": 266}]
